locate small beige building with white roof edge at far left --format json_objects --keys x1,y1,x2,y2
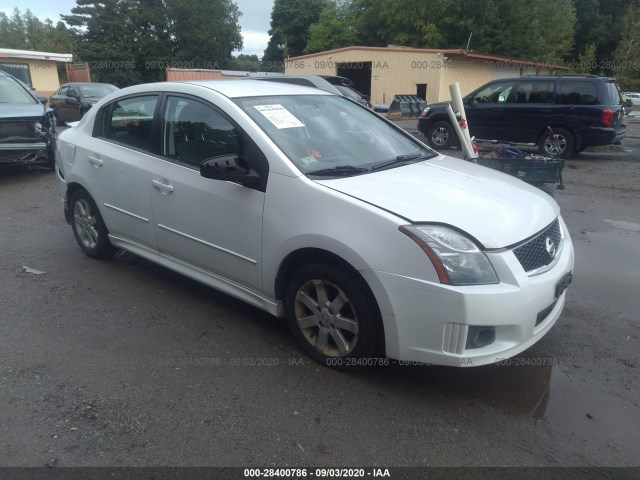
[{"x1": 0, "y1": 48, "x2": 72, "y2": 96}]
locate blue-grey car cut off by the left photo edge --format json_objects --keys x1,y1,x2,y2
[{"x1": 0, "y1": 71, "x2": 56, "y2": 166}]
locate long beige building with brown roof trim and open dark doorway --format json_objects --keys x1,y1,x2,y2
[{"x1": 285, "y1": 46, "x2": 569, "y2": 105}]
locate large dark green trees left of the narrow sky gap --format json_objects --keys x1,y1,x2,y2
[{"x1": 63, "y1": 0, "x2": 242, "y2": 86}]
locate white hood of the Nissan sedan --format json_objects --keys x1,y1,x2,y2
[{"x1": 317, "y1": 155, "x2": 560, "y2": 249}]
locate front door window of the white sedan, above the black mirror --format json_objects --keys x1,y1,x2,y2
[{"x1": 162, "y1": 97, "x2": 240, "y2": 167}]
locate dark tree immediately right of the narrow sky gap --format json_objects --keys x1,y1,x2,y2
[{"x1": 262, "y1": 0, "x2": 328, "y2": 71}]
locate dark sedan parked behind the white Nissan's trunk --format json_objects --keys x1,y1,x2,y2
[{"x1": 49, "y1": 82, "x2": 118, "y2": 125}]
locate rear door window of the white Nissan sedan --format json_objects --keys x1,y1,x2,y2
[{"x1": 101, "y1": 95, "x2": 158, "y2": 150}]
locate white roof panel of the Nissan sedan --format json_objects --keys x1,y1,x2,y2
[{"x1": 175, "y1": 79, "x2": 336, "y2": 98}]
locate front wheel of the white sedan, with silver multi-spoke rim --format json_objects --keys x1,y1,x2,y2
[{"x1": 285, "y1": 264, "x2": 382, "y2": 368}]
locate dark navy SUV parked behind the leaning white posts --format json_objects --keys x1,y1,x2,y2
[{"x1": 418, "y1": 75, "x2": 627, "y2": 158}]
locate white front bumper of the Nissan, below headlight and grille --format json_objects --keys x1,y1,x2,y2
[{"x1": 362, "y1": 223, "x2": 574, "y2": 366}]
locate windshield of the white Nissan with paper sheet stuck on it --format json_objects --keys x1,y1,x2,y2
[{"x1": 235, "y1": 95, "x2": 436, "y2": 175}]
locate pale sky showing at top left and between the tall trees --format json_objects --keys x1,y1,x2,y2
[{"x1": 0, "y1": 0, "x2": 273, "y2": 58}]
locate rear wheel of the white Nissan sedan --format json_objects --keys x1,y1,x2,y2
[{"x1": 69, "y1": 190, "x2": 116, "y2": 258}]
